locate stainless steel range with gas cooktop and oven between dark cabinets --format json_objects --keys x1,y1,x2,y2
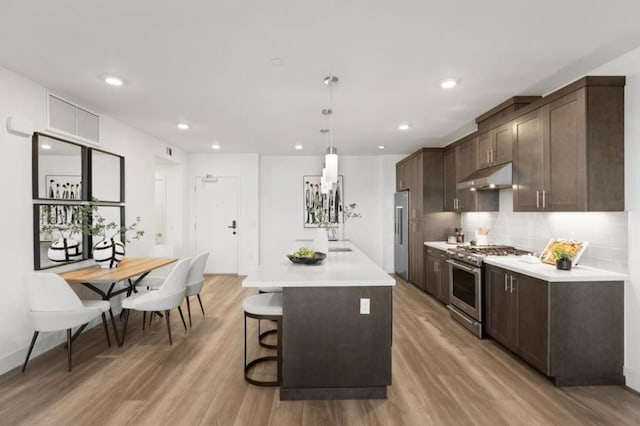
[{"x1": 447, "y1": 245, "x2": 530, "y2": 338}]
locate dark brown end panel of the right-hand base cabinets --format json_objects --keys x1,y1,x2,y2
[{"x1": 550, "y1": 281, "x2": 625, "y2": 386}]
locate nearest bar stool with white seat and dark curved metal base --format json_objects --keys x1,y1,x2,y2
[{"x1": 242, "y1": 293, "x2": 282, "y2": 386}]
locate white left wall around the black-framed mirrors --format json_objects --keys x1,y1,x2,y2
[{"x1": 0, "y1": 68, "x2": 184, "y2": 374}]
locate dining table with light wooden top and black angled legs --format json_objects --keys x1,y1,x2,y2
[{"x1": 60, "y1": 257, "x2": 178, "y2": 346}]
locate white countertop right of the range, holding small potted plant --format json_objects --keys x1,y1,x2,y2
[{"x1": 484, "y1": 256, "x2": 628, "y2": 282}]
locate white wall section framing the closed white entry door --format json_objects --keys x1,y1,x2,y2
[{"x1": 185, "y1": 154, "x2": 260, "y2": 275}]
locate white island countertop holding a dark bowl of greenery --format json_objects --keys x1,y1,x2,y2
[{"x1": 242, "y1": 241, "x2": 396, "y2": 287}]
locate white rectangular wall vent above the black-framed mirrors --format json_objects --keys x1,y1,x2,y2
[{"x1": 47, "y1": 92, "x2": 100, "y2": 144}]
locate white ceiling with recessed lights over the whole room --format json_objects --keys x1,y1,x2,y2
[{"x1": 0, "y1": 0, "x2": 640, "y2": 154}]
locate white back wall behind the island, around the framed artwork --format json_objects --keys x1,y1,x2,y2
[{"x1": 260, "y1": 155, "x2": 404, "y2": 272}]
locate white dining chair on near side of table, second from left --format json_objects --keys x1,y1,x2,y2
[{"x1": 122, "y1": 257, "x2": 191, "y2": 345}]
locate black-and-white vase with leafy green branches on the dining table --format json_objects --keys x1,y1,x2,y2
[{"x1": 83, "y1": 200, "x2": 144, "y2": 268}]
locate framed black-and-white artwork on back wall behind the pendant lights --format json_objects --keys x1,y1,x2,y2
[{"x1": 302, "y1": 175, "x2": 344, "y2": 228}]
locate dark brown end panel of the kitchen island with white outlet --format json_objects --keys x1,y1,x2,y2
[{"x1": 281, "y1": 286, "x2": 392, "y2": 399}]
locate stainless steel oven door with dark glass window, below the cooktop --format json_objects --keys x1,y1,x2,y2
[{"x1": 447, "y1": 259, "x2": 482, "y2": 322}]
